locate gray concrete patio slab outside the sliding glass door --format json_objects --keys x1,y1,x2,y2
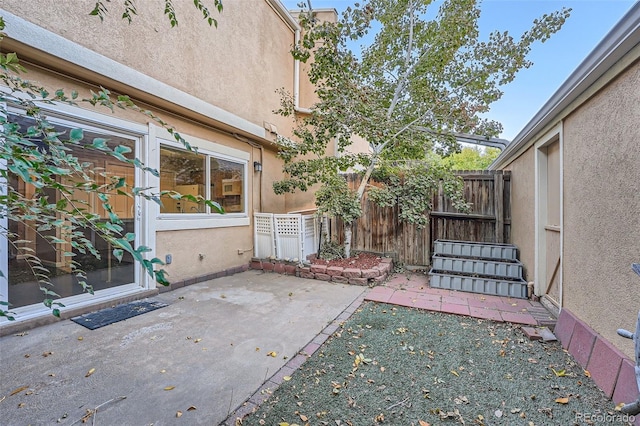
[{"x1": 0, "y1": 271, "x2": 366, "y2": 426}]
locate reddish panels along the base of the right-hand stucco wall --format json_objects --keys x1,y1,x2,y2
[{"x1": 555, "y1": 308, "x2": 640, "y2": 426}]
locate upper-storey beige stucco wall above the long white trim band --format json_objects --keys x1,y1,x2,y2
[{"x1": 0, "y1": 0, "x2": 294, "y2": 134}]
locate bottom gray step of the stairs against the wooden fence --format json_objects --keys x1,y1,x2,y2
[{"x1": 429, "y1": 270, "x2": 528, "y2": 299}]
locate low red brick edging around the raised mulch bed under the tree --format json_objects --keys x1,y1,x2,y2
[{"x1": 249, "y1": 257, "x2": 393, "y2": 286}]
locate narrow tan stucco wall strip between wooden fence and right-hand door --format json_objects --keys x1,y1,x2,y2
[{"x1": 504, "y1": 148, "x2": 535, "y2": 281}]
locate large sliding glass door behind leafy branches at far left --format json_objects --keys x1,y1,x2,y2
[{"x1": 0, "y1": 115, "x2": 139, "y2": 311}]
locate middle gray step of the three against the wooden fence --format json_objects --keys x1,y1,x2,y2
[{"x1": 432, "y1": 255, "x2": 522, "y2": 279}]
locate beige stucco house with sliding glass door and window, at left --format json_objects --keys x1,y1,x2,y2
[{"x1": 0, "y1": 0, "x2": 335, "y2": 331}]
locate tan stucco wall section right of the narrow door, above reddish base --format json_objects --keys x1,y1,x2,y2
[{"x1": 563, "y1": 64, "x2": 640, "y2": 356}]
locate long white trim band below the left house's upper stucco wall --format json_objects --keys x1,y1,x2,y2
[{"x1": 0, "y1": 9, "x2": 266, "y2": 139}]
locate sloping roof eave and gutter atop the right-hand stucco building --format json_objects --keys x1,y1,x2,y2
[{"x1": 489, "y1": 2, "x2": 640, "y2": 170}]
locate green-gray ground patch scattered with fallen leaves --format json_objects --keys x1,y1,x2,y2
[{"x1": 242, "y1": 302, "x2": 625, "y2": 426}]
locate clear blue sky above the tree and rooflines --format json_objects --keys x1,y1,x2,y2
[{"x1": 281, "y1": 0, "x2": 634, "y2": 140}]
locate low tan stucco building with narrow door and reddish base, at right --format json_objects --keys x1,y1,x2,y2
[{"x1": 492, "y1": 3, "x2": 640, "y2": 404}]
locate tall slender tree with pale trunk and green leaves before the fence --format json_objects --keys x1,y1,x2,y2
[{"x1": 274, "y1": 0, "x2": 570, "y2": 255}]
